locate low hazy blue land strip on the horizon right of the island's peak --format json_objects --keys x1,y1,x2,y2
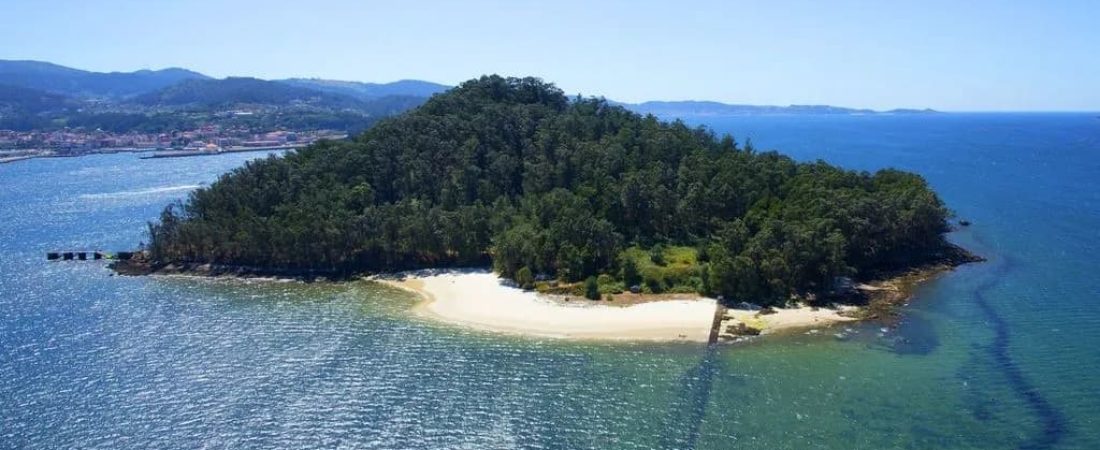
[{"x1": 619, "y1": 101, "x2": 936, "y2": 117}]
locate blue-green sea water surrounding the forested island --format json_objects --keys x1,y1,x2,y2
[{"x1": 0, "y1": 114, "x2": 1100, "y2": 449}]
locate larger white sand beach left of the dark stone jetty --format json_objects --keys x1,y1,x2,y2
[{"x1": 377, "y1": 271, "x2": 715, "y2": 342}]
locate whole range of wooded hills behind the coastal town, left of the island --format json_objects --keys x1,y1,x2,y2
[{"x1": 0, "y1": 61, "x2": 447, "y2": 133}]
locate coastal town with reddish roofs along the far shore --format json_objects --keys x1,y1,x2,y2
[{"x1": 0, "y1": 125, "x2": 347, "y2": 163}]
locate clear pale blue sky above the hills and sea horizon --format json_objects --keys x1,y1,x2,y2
[{"x1": 0, "y1": 0, "x2": 1100, "y2": 110}]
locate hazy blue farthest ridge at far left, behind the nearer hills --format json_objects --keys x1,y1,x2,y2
[{"x1": 0, "y1": 61, "x2": 209, "y2": 98}]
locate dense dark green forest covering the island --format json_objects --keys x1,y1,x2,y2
[{"x1": 147, "y1": 76, "x2": 952, "y2": 304}]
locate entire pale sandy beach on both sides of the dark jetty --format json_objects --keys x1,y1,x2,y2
[{"x1": 378, "y1": 271, "x2": 859, "y2": 343}]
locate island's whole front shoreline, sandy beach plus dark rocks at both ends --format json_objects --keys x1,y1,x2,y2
[{"x1": 109, "y1": 248, "x2": 981, "y2": 343}]
